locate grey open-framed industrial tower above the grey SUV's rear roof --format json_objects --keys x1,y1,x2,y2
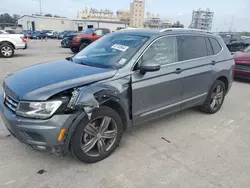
[{"x1": 189, "y1": 9, "x2": 214, "y2": 30}]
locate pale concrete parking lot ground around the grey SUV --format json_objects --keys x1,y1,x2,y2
[{"x1": 0, "y1": 40, "x2": 250, "y2": 188}]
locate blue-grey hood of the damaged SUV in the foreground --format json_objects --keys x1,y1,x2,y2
[{"x1": 4, "y1": 59, "x2": 117, "y2": 100}]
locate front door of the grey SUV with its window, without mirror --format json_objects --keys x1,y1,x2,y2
[{"x1": 132, "y1": 36, "x2": 182, "y2": 124}]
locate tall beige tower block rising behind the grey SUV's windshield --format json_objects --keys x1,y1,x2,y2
[{"x1": 129, "y1": 0, "x2": 145, "y2": 28}]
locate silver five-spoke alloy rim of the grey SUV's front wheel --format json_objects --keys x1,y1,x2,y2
[{"x1": 80, "y1": 116, "x2": 118, "y2": 157}]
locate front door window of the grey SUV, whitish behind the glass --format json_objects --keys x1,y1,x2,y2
[{"x1": 143, "y1": 37, "x2": 178, "y2": 65}]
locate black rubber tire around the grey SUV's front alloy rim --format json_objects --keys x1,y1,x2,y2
[{"x1": 70, "y1": 107, "x2": 123, "y2": 163}]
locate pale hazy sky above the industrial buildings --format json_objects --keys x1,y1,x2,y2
[{"x1": 0, "y1": 0, "x2": 250, "y2": 32}]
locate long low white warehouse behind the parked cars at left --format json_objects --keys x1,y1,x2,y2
[{"x1": 18, "y1": 15, "x2": 128, "y2": 32}]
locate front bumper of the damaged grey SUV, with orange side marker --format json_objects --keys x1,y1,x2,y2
[{"x1": 0, "y1": 90, "x2": 79, "y2": 153}]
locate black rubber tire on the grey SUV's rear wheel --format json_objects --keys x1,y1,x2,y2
[{"x1": 200, "y1": 80, "x2": 226, "y2": 114}]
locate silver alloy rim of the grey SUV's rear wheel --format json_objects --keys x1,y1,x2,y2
[{"x1": 210, "y1": 85, "x2": 224, "y2": 110}]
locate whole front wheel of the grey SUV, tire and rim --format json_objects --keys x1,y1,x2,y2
[{"x1": 70, "y1": 107, "x2": 123, "y2": 163}]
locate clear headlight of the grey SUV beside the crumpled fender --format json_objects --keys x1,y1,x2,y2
[{"x1": 16, "y1": 101, "x2": 62, "y2": 119}]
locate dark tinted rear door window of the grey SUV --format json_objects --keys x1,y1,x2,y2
[{"x1": 181, "y1": 36, "x2": 207, "y2": 60}]
